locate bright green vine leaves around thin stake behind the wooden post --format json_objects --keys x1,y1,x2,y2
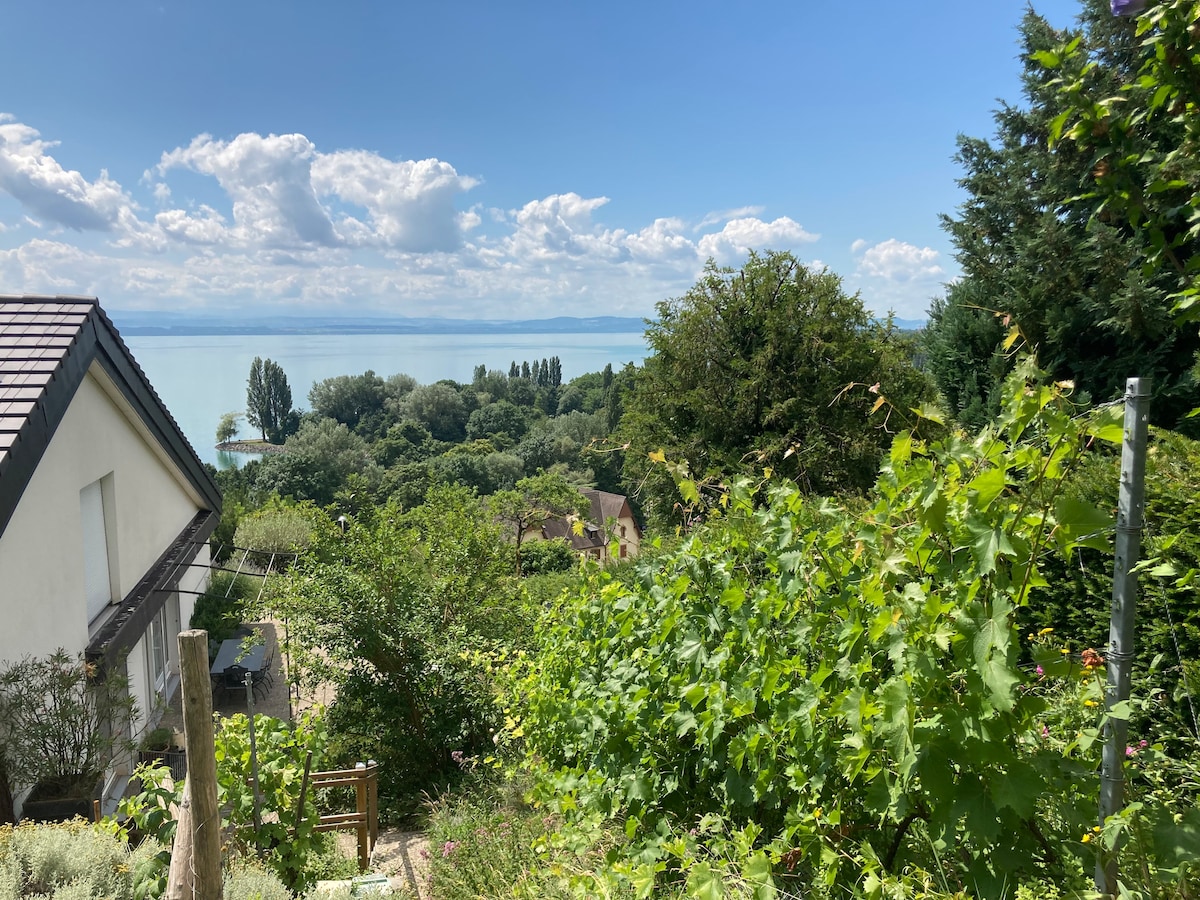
[{"x1": 121, "y1": 713, "x2": 328, "y2": 890}]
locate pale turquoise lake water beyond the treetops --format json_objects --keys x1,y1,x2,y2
[{"x1": 125, "y1": 334, "x2": 646, "y2": 468}]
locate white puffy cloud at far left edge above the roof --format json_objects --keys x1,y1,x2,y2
[{"x1": 0, "y1": 114, "x2": 134, "y2": 232}]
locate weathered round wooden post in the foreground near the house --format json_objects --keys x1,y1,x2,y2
[{"x1": 172, "y1": 629, "x2": 223, "y2": 900}]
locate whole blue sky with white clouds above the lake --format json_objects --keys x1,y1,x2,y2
[{"x1": 0, "y1": 0, "x2": 1079, "y2": 319}]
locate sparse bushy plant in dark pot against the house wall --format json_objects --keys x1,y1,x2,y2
[{"x1": 0, "y1": 649, "x2": 137, "y2": 821}]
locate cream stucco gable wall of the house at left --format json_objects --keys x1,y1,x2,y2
[{"x1": 0, "y1": 365, "x2": 208, "y2": 660}]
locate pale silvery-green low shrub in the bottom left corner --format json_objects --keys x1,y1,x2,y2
[{"x1": 0, "y1": 820, "x2": 161, "y2": 900}]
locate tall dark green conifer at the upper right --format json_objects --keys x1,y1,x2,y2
[{"x1": 926, "y1": 0, "x2": 1200, "y2": 427}]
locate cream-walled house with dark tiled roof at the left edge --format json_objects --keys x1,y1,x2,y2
[{"x1": 0, "y1": 295, "x2": 221, "y2": 811}]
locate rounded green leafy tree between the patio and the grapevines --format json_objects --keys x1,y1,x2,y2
[{"x1": 272, "y1": 494, "x2": 527, "y2": 802}]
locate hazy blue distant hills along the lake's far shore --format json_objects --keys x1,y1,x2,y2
[{"x1": 109, "y1": 310, "x2": 646, "y2": 336}]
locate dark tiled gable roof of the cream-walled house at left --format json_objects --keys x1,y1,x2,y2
[{"x1": 0, "y1": 294, "x2": 221, "y2": 534}]
